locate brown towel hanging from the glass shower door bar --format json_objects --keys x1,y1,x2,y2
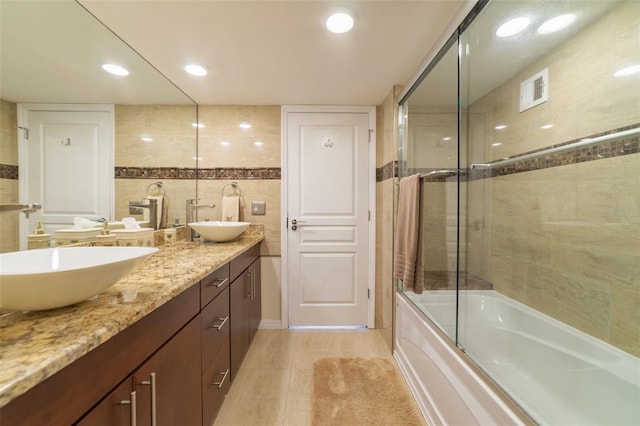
[{"x1": 393, "y1": 174, "x2": 424, "y2": 294}]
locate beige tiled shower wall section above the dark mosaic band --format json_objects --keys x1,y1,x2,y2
[{"x1": 470, "y1": 0, "x2": 640, "y2": 162}]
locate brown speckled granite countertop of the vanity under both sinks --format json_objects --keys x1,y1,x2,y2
[{"x1": 0, "y1": 225, "x2": 264, "y2": 407}]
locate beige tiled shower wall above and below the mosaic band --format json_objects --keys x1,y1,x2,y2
[{"x1": 466, "y1": 1, "x2": 640, "y2": 356}]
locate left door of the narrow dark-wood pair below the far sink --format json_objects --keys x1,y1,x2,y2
[{"x1": 229, "y1": 271, "x2": 251, "y2": 380}]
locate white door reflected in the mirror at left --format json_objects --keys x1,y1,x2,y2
[{"x1": 19, "y1": 104, "x2": 114, "y2": 249}]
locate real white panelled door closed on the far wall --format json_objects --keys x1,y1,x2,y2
[{"x1": 286, "y1": 108, "x2": 375, "y2": 326}]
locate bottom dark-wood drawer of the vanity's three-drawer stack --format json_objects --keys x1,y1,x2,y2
[{"x1": 202, "y1": 339, "x2": 231, "y2": 425}]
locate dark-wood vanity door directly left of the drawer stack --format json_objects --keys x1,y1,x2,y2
[{"x1": 133, "y1": 315, "x2": 202, "y2": 426}]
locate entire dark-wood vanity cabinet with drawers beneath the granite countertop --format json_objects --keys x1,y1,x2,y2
[{"x1": 0, "y1": 244, "x2": 261, "y2": 426}]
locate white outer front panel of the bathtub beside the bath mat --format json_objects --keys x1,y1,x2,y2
[{"x1": 394, "y1": 294, "x2": 533, "y2": 425}]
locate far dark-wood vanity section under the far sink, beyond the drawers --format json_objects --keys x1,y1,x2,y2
[{"x1": 230, "y1": 246, "x2": 262, "y2": 380}]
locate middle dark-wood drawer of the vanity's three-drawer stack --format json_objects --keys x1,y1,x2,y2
[{"x1": 201, "y1": 286, "x2": 231, "y2": 371}]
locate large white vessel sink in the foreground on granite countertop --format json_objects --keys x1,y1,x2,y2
[{"x1": 0, "y1": 247, "x2": 158, "y2": 311}]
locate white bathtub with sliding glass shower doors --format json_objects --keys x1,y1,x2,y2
[{"x1": 396, "y1": 290, "x2": 640, "y2": 425}]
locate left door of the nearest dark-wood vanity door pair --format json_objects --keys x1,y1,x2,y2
[{"x1": 76, "y1": 378, "x2": 137, "y2": 426}]
